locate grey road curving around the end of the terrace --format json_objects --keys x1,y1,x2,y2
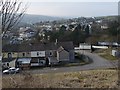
[{"x1": 24, "y1": 51, "x2": 117, "y2": 74}]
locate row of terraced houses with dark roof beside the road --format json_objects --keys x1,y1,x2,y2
[{"x1": 2, "y1": 42, "x2": 74, "y2": 67}]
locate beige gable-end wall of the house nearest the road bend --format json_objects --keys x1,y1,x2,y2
[{"x1": 57, "y1": 50, "x2": 69, "y2": 61}]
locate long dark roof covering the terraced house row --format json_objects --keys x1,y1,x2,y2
[{"x1": 2, "y1": 42, "x2": 74, "y2": 52}]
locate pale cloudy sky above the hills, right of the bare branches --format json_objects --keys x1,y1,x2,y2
[{"x1": 23, "y1": 0, "x2": 119, "y2": 17}]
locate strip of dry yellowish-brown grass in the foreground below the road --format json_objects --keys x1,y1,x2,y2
[{"x1": 2, "y1": 70, "x2": 118, "y2": 88}]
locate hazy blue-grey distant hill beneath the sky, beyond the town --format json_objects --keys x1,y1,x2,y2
[{"x1": 22, "y1": 14, "x2": 63, "y2": 24}]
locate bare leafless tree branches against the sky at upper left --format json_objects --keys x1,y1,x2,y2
[{"x1": 0, "y1": 0, "x2": 27, "y2": 36}]
